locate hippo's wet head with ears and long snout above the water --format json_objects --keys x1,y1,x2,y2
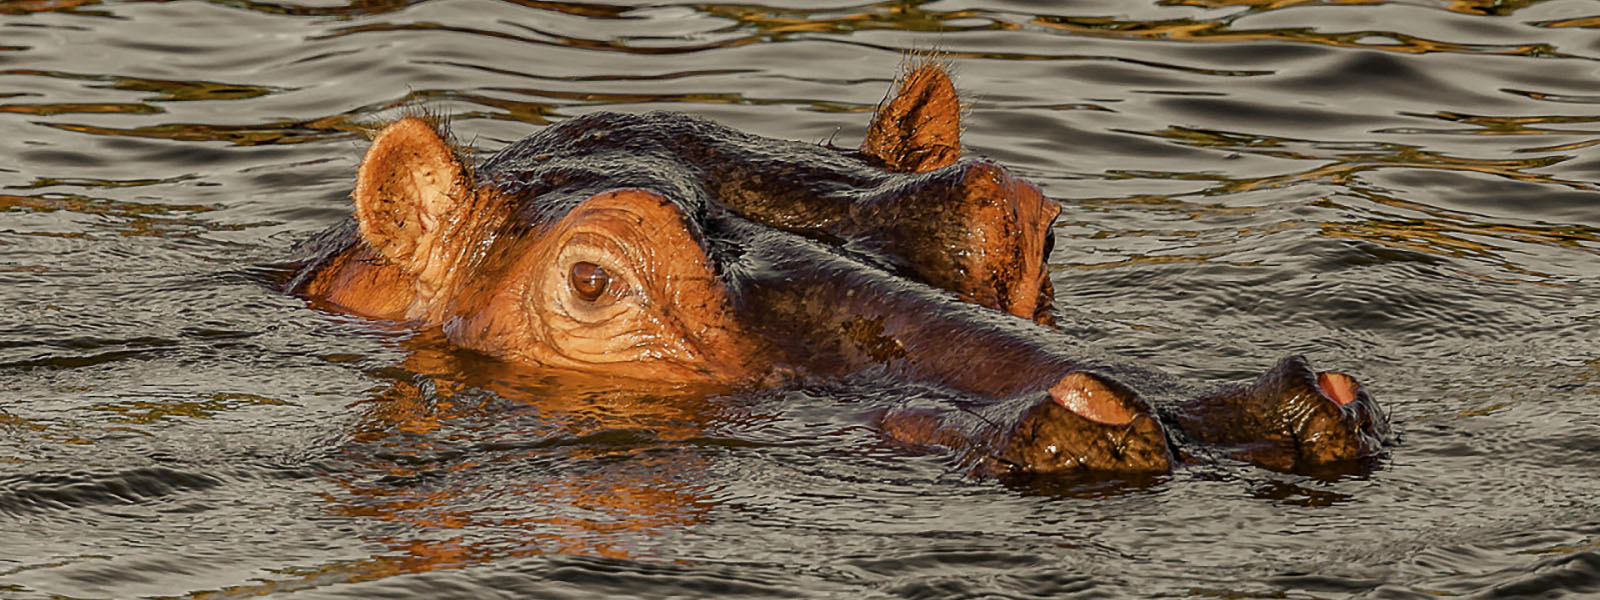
[{"x1": 291, "y1": 66, "x2": 1387, "y2": 483}]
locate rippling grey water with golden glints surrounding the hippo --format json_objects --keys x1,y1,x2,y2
[{"x1": 0, "y1": 0, "x2": 1600, "y2": 598}]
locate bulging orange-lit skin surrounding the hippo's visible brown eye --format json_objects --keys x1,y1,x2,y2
[{"x1": 445, "y1": 190, "x2": 770, "y2": 382}]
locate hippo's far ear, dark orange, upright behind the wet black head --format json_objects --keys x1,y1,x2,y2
[{"x1": 861, "y1": 64, "x2": 962, "y2": 173}]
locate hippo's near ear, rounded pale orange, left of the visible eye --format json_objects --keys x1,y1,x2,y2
[{"x1": 354, "y1": 117, "x2": 470, "y2": 280}]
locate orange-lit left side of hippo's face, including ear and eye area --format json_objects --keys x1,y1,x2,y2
[{"x1": 301, "y1": 118, "x2": 771, "y2": 384}]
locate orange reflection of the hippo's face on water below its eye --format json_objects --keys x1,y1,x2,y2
[{"x1": 190, "y1": 333, "x2": 732, "y2": 598}]
